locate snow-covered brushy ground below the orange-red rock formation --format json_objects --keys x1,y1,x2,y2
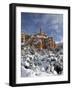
[{"x1": 21, "y1": 46, "x2": 63, "y2": 77}]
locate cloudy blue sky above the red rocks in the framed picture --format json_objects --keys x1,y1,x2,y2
[{"x1": 21, "y1": 12, "x2": 63, "y2": 42}]
